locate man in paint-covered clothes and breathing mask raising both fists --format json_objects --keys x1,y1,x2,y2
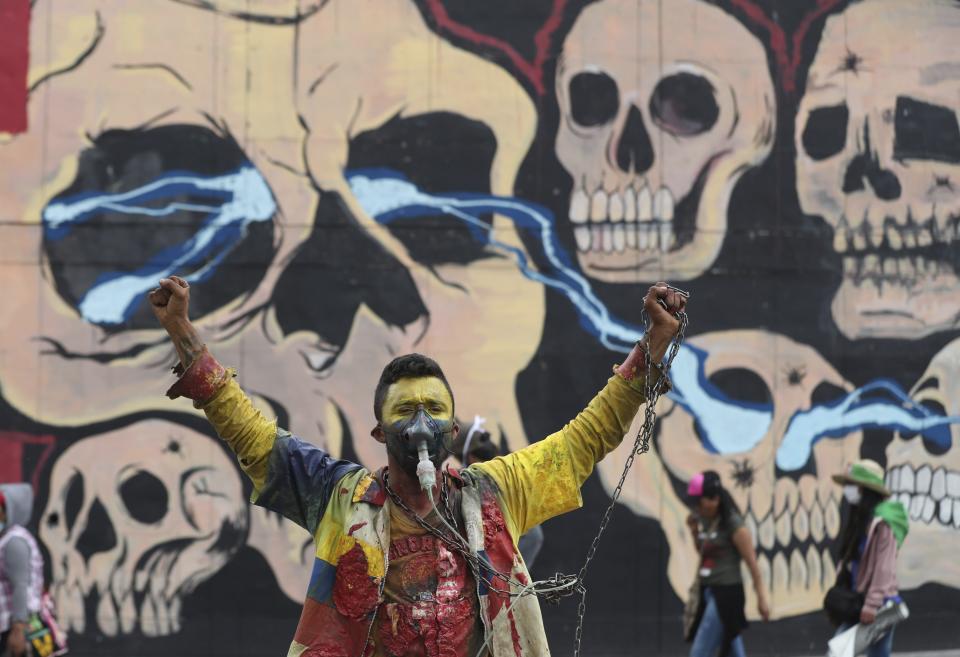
[{"x1": 149, "y1": 276, "x2": 685, "y2": 657}]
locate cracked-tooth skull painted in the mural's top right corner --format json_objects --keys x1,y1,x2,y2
[{"x1": 796, "y1": 0, "x2": 960, "y2": 339}]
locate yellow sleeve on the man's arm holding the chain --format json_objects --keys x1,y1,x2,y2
[{"x1": 471, "y1": 374, "x2": 644, "y2": 540}]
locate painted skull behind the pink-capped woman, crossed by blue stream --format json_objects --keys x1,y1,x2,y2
[{"x1": 598, "y1": 330, "x2": 862, "y2": 618}]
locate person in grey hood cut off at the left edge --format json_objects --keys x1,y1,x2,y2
[{"x1": 0, "y1": 484, "x2": 43, "y2": 657}]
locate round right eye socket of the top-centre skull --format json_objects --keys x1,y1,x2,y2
[{"x1": 650, "y1": 73, "x2": 720, "y2": 137}]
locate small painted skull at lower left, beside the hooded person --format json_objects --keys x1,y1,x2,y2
[{"x1": 39, "y1": 420, "x2": 247, "y2": 637}]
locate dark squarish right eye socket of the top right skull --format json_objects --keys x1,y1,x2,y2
[{"x1": 893, "y1": 96, "x2": 960, "y2": 164}]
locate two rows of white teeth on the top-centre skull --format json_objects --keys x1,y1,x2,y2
[{"x1": 570, "y1": 185, "x2": 677, "y2": 253}]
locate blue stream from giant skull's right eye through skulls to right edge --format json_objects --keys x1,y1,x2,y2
[{"x1": 346, "y1": 169, "x2": 960, "y2": 471}]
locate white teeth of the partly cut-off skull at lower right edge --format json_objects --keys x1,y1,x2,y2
[{"x1": 886, "y1": 464, "x2": 960, "y2": 529}]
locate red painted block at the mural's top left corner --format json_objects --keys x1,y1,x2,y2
[{"x1": 0, "y1": 0, "x2": 30, "y2": 132}]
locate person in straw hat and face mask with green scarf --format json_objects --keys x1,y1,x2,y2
[{"x1": 833, "y1": 459, "x2": 909, "y2": 657}]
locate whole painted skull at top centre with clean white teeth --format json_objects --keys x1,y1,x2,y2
[{"x1": 555, "y1": 0, "x2": 776, "y2": 283}]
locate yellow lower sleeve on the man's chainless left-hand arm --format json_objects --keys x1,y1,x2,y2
[{"x1": 200, "y1": 378, "x2": 277, "y2": 495}]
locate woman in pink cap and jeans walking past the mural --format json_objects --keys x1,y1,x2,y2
[{"x1": 687, "y1": 470, "x2": 770, "y2": 657}]
